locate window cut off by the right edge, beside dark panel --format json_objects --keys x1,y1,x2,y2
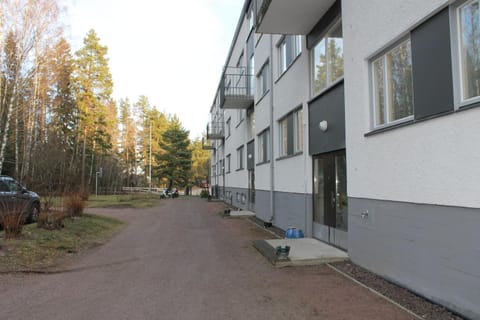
[{"x1": 456, "y1": 0, "x2": 480, "y2": 102}]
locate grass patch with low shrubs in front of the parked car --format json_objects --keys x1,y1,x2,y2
[{"x1": 0, "y1": 214, "x2": 124, "y2": 272}]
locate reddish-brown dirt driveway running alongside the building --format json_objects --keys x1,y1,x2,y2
[{"x1": 0, "y1": 198, "x2": 412, "y2": 320}]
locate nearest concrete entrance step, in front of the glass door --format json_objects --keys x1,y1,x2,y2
[{"x1": 253, "y1": 238, "x2": 348, "y2": 267}]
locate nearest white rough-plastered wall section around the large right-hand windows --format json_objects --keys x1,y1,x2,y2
[{"x1": 342, "y1": 0, "x2": 480, "y2": 208}]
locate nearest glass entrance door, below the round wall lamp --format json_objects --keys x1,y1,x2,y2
[{"x1": 313, "y1": 150, "x2": 348, "y2": 249}]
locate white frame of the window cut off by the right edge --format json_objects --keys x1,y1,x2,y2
[{"x1": 450, "y1": 0, "x2": 480, "y2": 110}]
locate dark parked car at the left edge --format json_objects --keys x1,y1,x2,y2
[{"x1": 0, "y1": 176, "x2": 40, "y2": 223}]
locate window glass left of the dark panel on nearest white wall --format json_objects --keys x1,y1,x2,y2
[{"x1": 372, "y1": 39, "x2": 413, "y2": 126}]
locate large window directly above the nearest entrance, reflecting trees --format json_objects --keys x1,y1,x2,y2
[{"x1": 312, "y1": 21, "x2": 343, "y2": 95}]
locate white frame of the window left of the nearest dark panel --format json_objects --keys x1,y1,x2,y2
[{"x1": 369, "y1": 38, "x2": 415, "y2": 130}]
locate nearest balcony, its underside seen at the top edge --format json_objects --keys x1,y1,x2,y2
[{"x1": 256, "y1": 0, "x2": 335, "y2": 35}]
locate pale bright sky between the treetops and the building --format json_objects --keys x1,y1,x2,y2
[{"x1": 65, "y1": 0, "x2": 244, "y2": 138}]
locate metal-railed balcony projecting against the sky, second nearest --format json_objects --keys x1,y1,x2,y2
[{"x1": 220, "y1": 67, "x2": 255, "y2": 109}]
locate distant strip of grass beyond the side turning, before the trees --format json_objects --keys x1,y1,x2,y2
[{"x1": 87, "y1": 193, "x2": 160, "y2": 209}]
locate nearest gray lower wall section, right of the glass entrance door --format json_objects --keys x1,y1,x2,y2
[{"x1": 348, "y1": 198, "x2": 480, "y2": 319}]
